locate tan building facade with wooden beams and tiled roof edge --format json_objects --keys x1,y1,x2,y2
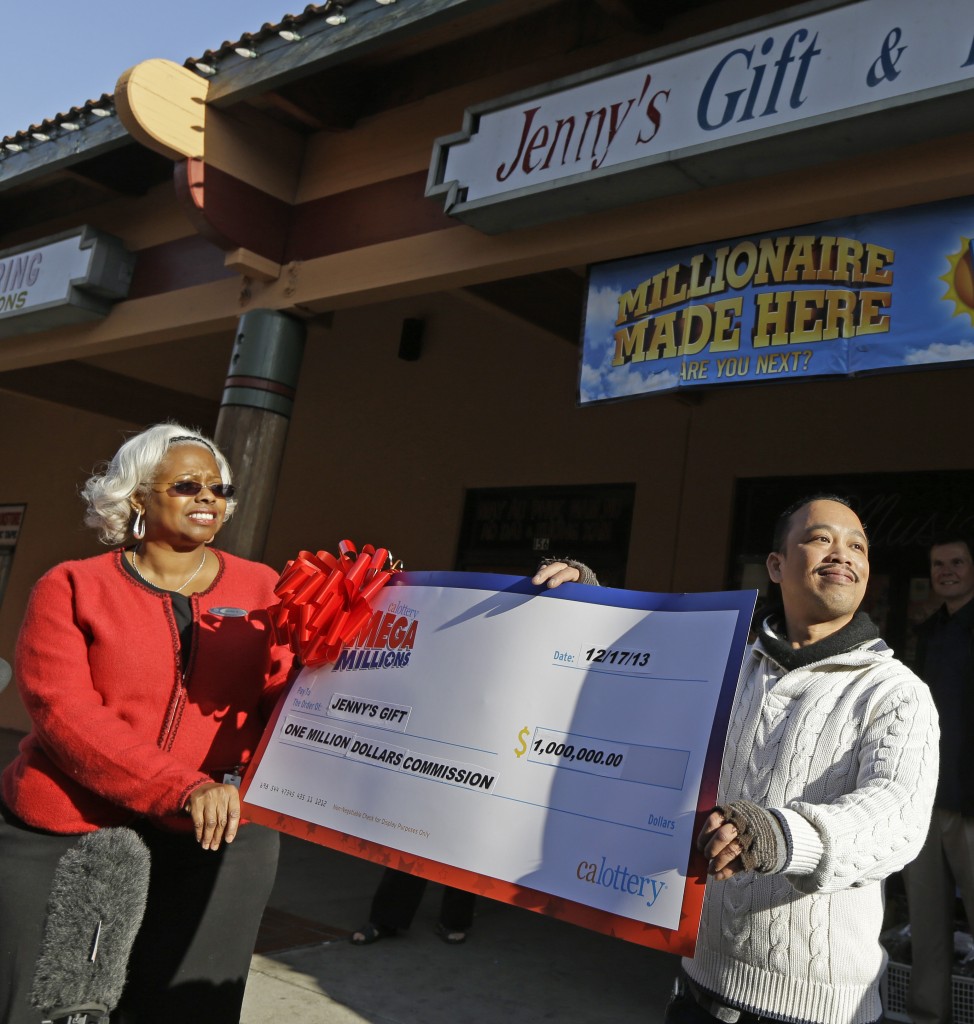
[{"x1": 0, "y1": 0, "x2": 974, "y2": 728}]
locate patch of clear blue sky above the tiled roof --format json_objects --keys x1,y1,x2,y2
[{"x1": 0, "y1": 0, "x2": 284, "y2": 137}]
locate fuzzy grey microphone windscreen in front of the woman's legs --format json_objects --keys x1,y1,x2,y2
[{"x1": 31, "y1": 827, "x2": 150, "y2": 1024}]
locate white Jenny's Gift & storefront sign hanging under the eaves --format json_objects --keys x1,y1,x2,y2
[{"x1": 427, "y1": 0, "x2": 974, "y2": 231}]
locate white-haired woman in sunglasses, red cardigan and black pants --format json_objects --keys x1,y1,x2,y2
[{"x1": 0, "y1": 424, "x2": 291, "y2": 1024}]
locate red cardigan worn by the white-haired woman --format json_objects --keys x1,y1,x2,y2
[{"x1": 0, "y1": 549, "x2": 291, "y2": 833}]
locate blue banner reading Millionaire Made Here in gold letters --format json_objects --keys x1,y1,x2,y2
[{"x1": 579, "y1": 198, "x2": 974, "y2": 404}]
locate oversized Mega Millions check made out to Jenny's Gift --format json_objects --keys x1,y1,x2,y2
[{"x1": 244, "y1": 572, "x2": 755, "y2": 952}]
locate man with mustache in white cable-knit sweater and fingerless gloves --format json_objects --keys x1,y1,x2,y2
[{"x1": 535, "y1": 496, "x2": 939, "y2": 1024}]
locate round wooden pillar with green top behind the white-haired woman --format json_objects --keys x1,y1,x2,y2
[{"x1": 214, "y1": 309, "x2": 306, "y2": 561}]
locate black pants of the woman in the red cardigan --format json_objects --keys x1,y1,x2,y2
[{"x1": 0, "y1": 812, "x2": 280, "y2": 1024}]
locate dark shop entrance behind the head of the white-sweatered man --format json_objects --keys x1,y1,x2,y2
[{"x1": 727, "y1": 470, "x2": 974, "y2": 664}]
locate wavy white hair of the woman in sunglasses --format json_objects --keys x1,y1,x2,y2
[{"x1": 81, "y1": 423, "x2": 237, "y2": 545}]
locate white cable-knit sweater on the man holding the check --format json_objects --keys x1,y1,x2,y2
[{"x1": 683, "y1": 641, "x2": 939, "y2": 1024}]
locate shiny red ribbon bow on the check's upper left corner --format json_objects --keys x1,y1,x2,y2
[{"x1": 270, "y1": 541, "x2": 401, "y2": 668}]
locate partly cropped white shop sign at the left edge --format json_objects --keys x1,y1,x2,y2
[{"x1": 0, "y1": 227, "x2": 135, "y2": 338}]
